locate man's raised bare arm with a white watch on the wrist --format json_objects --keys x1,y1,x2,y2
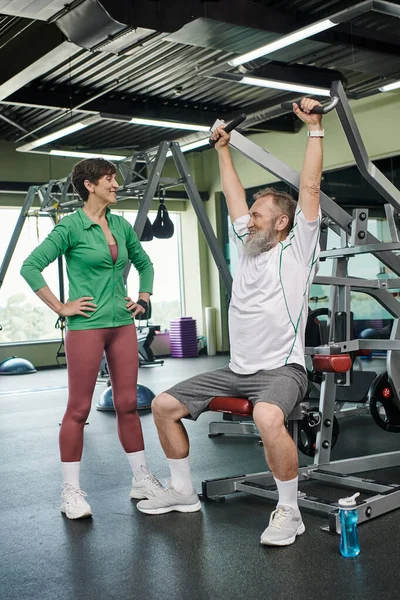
[{"x1": 293, "y1": 98, "x2": 323, "y2": 221}]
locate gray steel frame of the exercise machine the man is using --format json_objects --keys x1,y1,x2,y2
[{"x1": 203, "y1": 82, "x2": 400, "y2": 533}]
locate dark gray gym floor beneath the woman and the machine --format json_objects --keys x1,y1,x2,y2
[{"x1": 0, "y1": 356, "x2": 400, "y2": 600}]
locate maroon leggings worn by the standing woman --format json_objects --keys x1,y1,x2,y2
[{"x1": 60, "y1": 323, "x2": 144, "y2": 462}]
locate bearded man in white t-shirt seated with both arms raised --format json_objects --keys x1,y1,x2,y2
[{"x1": 137, "y1": 98, "x2": 324, "y2": 546}]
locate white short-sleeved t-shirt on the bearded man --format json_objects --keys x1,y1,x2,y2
[{"x1": 229, "y1": 210, "x2": 321, "y2": 375}]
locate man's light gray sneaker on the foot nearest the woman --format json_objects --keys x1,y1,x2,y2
[{"x1": 137, "y1": 486, "x2": 201, "y2": 515}]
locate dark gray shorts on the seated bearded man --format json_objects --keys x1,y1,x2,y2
[{"x1": 166, "y1": 365, "x2": 307, "y2": 419}]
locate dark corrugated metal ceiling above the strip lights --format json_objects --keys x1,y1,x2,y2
[{"x1": 0, "y1": 0, "x2": 400, "y2": 155}]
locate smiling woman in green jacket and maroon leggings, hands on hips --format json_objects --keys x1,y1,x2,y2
[{"x1": 21, "y1": 158, "x2": 159, "y2": 519}]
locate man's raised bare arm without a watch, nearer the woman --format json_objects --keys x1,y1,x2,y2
[{"x1": 212, "y1": 127, "x2": 249, "y2": 223}]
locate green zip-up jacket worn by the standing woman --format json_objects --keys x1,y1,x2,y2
[{"x1": 21, "y1": 208, "x2": 154, "y2": 330}]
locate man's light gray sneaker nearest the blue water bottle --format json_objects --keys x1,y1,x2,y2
[{"x1": 260, "y1": 505, "x2": 306, "y2": 546}]
